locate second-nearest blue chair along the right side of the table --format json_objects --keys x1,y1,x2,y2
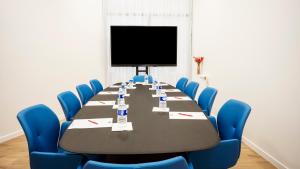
[{"x1": 198, "y1": 87, "x2": 218, "y2": 116}]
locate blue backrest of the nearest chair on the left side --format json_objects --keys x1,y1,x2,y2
[{"x1": 17, "y1": 104, "x2": 60, "y2": 154}]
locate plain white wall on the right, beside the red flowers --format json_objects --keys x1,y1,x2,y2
[{"x1": 193, "y1": 0, "x2": 300, "y2": 169}]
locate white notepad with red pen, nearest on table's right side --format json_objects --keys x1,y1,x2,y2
[{"x1": 169, "y1": 112, "x2": 207, "y2": 120}]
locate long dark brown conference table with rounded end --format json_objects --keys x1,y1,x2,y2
[{"x1": 59, "y1": 83, "x2": 219, "y2": 158}]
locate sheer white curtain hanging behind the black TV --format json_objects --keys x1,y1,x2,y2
[{"x1": 103, "y1": 0, "x2": 192, "y2": 84}]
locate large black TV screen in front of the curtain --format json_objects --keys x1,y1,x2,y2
[{"x1": 110, "y1": 26, "x2": 177, "y2": 66}]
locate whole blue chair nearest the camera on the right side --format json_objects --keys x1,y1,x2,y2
[{"x1": 188, "y1": 99, "x2": 251, "y2": 169}]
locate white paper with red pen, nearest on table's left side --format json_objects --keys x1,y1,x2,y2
[{"x1": 68, "y1": 118, "x2": 113, "y2": 129}]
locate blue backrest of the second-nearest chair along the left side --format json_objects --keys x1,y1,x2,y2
[{"x1": 57, "y1": 91, "x2": 81, "y2": 121}]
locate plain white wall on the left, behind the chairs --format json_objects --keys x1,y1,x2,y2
[{"x1": 0, "y1": 0, "x2": 106, "y2": 141}]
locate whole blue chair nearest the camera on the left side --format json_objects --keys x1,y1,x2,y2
[{"x1": 17, "y1": 104, "x2": 82, "y2": 169}]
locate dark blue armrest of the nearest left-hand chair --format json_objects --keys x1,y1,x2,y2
[{"x1": 30, "y1": 151, "x2": 82, "y2": 169}]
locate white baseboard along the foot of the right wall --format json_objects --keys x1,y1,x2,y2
[{"x1": 243, "y1": 137, "x2": 289, "y2": 169}]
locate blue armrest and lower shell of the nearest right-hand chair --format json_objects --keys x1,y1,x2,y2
[{"x1": 188, "y1": 139, "x2": 241, "y2": 168}]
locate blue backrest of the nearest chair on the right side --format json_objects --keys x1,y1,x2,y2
[{"x1": 217, "y1": 99, "x2": 251, "y2": 140}]
